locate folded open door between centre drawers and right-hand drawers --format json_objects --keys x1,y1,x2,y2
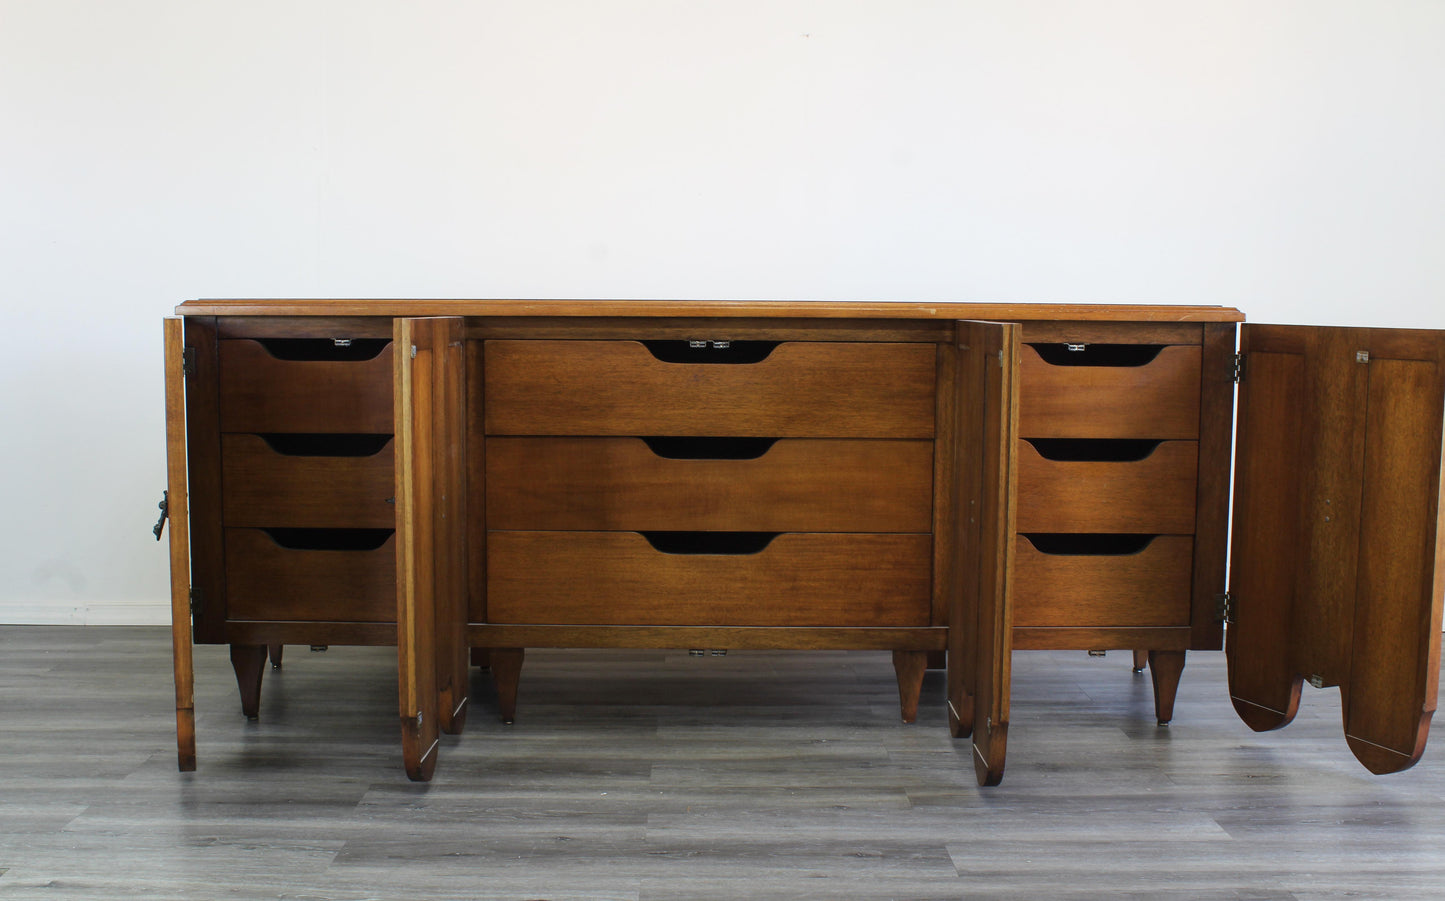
[{"x1": 945, "y1": 322, "x2": 1019, "y2": 785}]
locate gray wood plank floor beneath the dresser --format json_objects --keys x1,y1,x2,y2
[{"x1": 0, "y1": 627, "x2": 1445, "y2": 900}]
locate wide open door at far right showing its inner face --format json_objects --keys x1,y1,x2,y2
[{"x1": 1225, "y1": 325, "x2": 1445, "y2": 774}]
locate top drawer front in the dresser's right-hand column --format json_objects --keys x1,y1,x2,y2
[{"x1": 1019, "y1": 345, "x2": 1199, "y2": 439}]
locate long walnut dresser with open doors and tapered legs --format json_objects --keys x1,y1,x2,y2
[{"x1": 158, "y1": 300, "x2": 1445, "y2": 784}]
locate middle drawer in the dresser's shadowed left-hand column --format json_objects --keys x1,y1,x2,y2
[{"x1": 221, "y1": 435, "x2": 396, "y2": 528}]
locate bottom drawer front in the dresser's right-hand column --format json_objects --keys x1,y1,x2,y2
[{"x1": 1013, "y1": 536, "x2": 1194, "y2": 628}]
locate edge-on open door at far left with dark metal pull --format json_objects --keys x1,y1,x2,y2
[{"x1": 156, "y1": 318, "x2": 195, "y2": 772}]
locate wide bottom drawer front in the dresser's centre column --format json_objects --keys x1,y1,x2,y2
[{"x1": 487, "y1": 531, "x2": 932, "y2": 627}]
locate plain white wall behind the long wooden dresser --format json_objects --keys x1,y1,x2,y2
[{"x1": 0, "y1": 0, "x2": 1445, "y2": 622}]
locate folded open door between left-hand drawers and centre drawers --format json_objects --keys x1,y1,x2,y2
[{"x1": 392, "y1": 316, "x2": 467, "y2": 781}]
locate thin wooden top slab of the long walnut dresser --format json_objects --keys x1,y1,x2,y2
[{"x1": 176, "y1": 299, "x2": 1244, "y2": 322}]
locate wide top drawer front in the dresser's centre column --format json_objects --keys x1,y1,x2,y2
[{"x1": 486, "y1": 341, "x2": 936, "y2": 438}]
